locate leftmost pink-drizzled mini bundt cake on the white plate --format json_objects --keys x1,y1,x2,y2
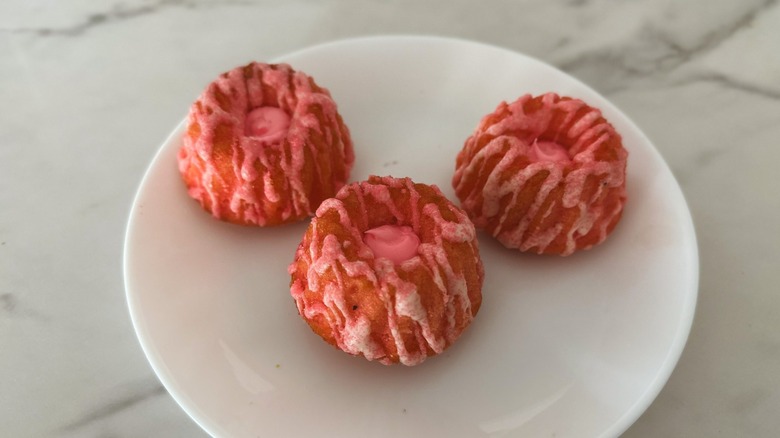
[{"x1": 178, "y1": 62, "x2": 354, "y2": 226}]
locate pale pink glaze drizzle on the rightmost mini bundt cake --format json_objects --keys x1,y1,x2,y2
[{"x1": 453, "y1": 93, "x2": 627, "y2": 255}]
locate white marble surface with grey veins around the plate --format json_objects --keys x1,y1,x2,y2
[{"x1": 0, "y1": 0, "x2": 780, "y2": 438}]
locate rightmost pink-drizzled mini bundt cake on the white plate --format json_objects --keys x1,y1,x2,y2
[{"x1": 452, "y1": 93, "x2": 628, "y2": 256}]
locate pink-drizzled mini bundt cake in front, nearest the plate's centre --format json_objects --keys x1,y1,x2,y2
[{"x1": 289, "y1": 176, "x2": 484, "y2": 365}]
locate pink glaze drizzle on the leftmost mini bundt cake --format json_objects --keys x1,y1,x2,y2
[{"x1": 179, "y1": 63, "x2": 354, "y2": 226}]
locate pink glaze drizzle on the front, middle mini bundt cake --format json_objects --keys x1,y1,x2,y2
[{"x1": 289, "y1": 177, "x2": 482, "y2": 365}]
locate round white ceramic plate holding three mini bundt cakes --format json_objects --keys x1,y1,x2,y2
[{"x1": 125, "y1": 37, "x2": 698, "y2": 438}]
